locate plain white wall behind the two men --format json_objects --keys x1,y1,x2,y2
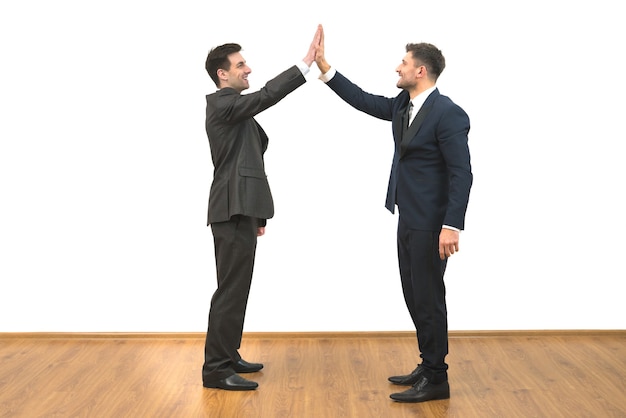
[{"x1": 0, "y1": 0, "x2": 626, "y2": 332}]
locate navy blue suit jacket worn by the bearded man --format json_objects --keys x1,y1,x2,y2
[{"x1": 327, "y1": 72, "x2": 473, "y2": 231}]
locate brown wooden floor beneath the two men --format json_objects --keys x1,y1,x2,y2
[{"x1": 0, "y1": 331, "x2": 626, "y2": 418}]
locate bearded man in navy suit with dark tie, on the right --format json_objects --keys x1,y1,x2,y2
[{"x1": 316, "y1": 25, "x2": 472, "y2": 402}]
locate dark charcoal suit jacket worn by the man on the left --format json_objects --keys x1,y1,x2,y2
[{"x1": 206, "y1": 66, "x2": 306, "y2": 224}]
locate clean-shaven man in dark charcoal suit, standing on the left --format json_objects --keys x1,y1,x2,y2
[{"x1": 202, "y1": 28, "x2": 321, "y2": 390}]
